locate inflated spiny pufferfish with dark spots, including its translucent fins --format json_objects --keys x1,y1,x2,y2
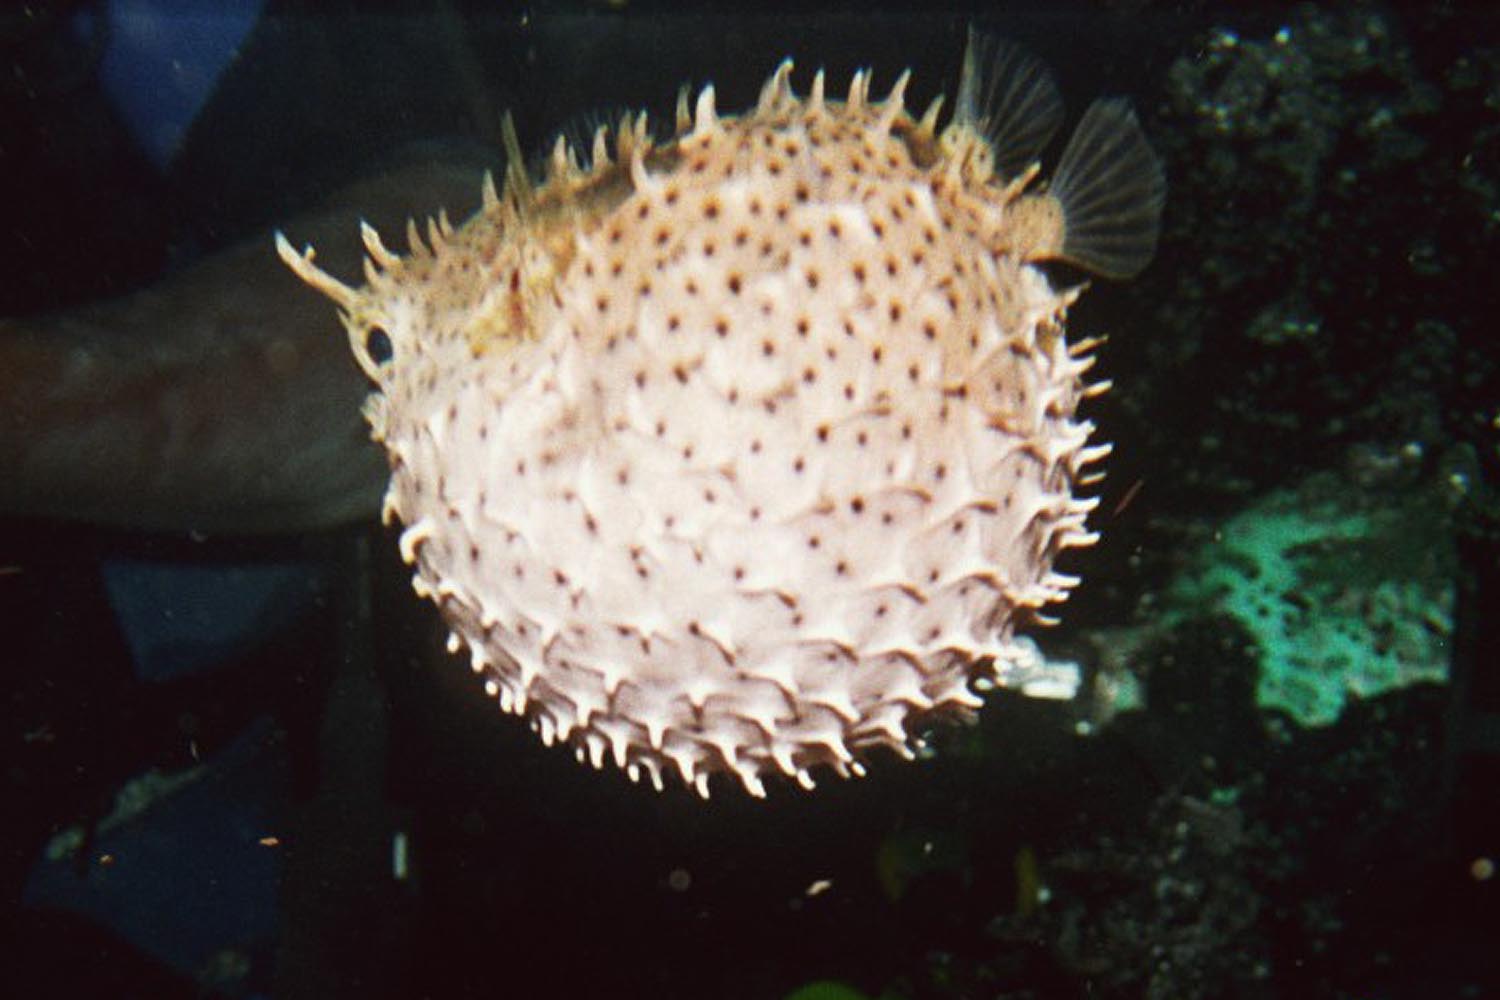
[{"x1": 278, "y1": 36, "x2": 1164, "y2": 796}]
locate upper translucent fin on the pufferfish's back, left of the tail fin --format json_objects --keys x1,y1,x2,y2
[{"x1": 953, "y1": 25, "x2": 1062, "y2": 178}]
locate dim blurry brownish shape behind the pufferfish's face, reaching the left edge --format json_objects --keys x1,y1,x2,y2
[{"x1": 0, "y1": 163, "x2": 479, "y2": 534}]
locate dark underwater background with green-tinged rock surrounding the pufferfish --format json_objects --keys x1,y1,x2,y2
[{"x1": 0, "y1": 0, "x2": 1500, "y2": 1000}]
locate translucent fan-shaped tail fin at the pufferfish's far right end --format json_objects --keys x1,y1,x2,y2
[{"x1": 1050, "y1": 97, "x2": 1167, "y2": 277}]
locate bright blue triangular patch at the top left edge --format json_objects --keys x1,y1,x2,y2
[{"x1": 74, "y1": 0, "x2": 266, "y2": 169}]
